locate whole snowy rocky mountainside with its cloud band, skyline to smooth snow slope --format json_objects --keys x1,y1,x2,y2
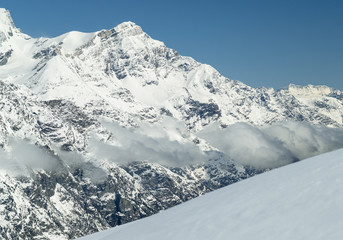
[{"x1": 0, "y1": 9, "x2": 343, "y2": 239}]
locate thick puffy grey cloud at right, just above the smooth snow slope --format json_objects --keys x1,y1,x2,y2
[{"x1": 198, "y1": 122, "x2": 343, "y2": 169}]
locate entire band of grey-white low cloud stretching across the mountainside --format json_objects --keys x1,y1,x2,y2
[{"x1": 0, "y1": 118, "x2": 343, "y2": 174}]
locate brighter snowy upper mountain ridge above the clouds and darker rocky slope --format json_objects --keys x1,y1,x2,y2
[{"x1": 0, "y1": 10, "x2": 343, "y2": 131}]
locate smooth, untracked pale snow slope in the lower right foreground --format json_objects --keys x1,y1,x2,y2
[{"x1": 80, "y1": 149, "x2": 343, "y2": 240}]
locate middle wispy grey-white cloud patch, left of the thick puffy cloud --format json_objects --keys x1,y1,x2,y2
[{"x1": 87, "y1": 119, "x2": 208, "y2": 167}]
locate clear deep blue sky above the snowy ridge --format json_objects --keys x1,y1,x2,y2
[{"x1": 0, "y1": 0, "x2": 343, "y2": 90}]
